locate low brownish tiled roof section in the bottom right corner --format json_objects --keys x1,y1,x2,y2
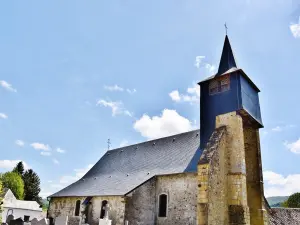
[{"x1": 269, "y1": 208, "x2": 300, "y2": 225}]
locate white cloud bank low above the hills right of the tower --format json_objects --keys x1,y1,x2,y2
[{"x1": 263, "y1": 171, "x2": 300, "y2": 197}]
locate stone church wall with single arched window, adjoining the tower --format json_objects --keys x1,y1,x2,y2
[{"x1": 125, "y1": 173, "x2": 198, "y2": 225}]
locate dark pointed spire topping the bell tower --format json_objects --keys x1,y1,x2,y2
[{"x1": 218, "y1": 35, "x2": 237, "y2": 75}]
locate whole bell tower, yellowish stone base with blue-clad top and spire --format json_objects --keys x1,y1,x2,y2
[{"x1": 198, "y1": 34, "x2": 268, "y2": 225}]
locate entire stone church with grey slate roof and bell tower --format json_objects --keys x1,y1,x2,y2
[{"x1": 48, "y1": 35, "x2": 300, "y2": 225}]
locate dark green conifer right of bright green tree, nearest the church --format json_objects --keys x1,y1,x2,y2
[{"x1": 23, "y1": 169, "x2": 41, "y2": 202}]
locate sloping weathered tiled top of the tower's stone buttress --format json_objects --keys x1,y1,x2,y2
[{"x1": 199, "y1": 126, "x2": 226, "y2": 164}]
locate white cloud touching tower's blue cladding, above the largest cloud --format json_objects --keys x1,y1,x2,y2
[{"x1": 169, "y1": 84, "x2": 200, "y2": 104}]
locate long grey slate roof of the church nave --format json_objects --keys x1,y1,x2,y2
[{"x1": 50, "y1": 130, "x2": 201, "y2": 197}]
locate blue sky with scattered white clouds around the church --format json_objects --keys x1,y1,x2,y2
[{"x1": 0, "y1": 0, "x2": 300, "y2": 197}]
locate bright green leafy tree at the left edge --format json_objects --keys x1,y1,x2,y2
[{"x1": 1, "y1": 172, "x2": 24, "y2": 199}]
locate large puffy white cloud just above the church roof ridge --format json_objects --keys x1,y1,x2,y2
[{"x1": 133, "y1": 109, "x2": 193, "y2": 139}]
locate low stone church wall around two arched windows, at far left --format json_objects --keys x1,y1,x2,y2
[{"x1": 48, "y1": 196, "x2": 125, "y2": 225}]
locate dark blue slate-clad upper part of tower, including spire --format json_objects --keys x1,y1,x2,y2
[{"x1": 199, "y1": 35, "x2": 263, "y2": 149}]
